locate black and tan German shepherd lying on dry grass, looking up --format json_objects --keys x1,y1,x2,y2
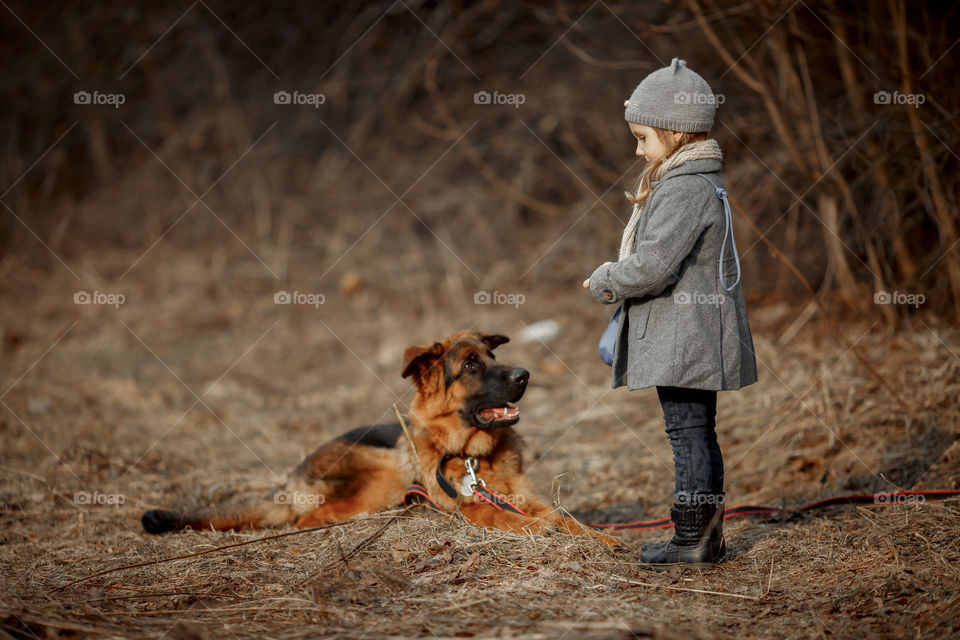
[{"x1": 142, "y1": 331, "x2": 620, "y2": 547}]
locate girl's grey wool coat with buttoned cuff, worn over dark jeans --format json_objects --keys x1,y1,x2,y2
[{"x1": 590, "y1": 159, "x2": 757, "y2": 391}]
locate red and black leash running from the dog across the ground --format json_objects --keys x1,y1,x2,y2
[{"x1": 403, "y1": 484, "x2": 960, "y2": 532}]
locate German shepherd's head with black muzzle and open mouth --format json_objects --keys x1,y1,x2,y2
[{"x1": 403, "y1": 331, "x2": 530, "y2": 430}]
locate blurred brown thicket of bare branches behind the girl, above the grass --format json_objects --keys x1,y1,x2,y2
[{"x1": 0, "y1": 1, "x2": 960, "y2": 318}]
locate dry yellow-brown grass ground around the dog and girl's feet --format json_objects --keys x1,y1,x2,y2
[{"x1": 0, "y1": 242, "x2": 960, "y2": 638}]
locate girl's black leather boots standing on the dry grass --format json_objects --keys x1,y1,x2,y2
[{"x1": 640, "y1": 494, "x2": 726, "y2": 569}]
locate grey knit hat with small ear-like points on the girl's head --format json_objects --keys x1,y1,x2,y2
[{"x1": 624, "y1": 58, "x2": 717, "y2": 133}]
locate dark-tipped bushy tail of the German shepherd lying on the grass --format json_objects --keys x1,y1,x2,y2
[{"x1": 140, "y1": 492, "x2": 297, "y2": 533}]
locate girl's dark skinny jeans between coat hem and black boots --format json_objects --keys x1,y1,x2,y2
[{"x1": 657, "y1": 387, "x2": 723, "y2": 500}]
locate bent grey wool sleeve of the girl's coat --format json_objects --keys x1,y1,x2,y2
[{"x1": 590, "y1": 175, "x2": 716, "y2": 304}]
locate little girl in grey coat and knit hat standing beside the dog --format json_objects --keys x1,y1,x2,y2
[{"x1": 583, "y1": 58, "x2": 757, "y2": 566}]
